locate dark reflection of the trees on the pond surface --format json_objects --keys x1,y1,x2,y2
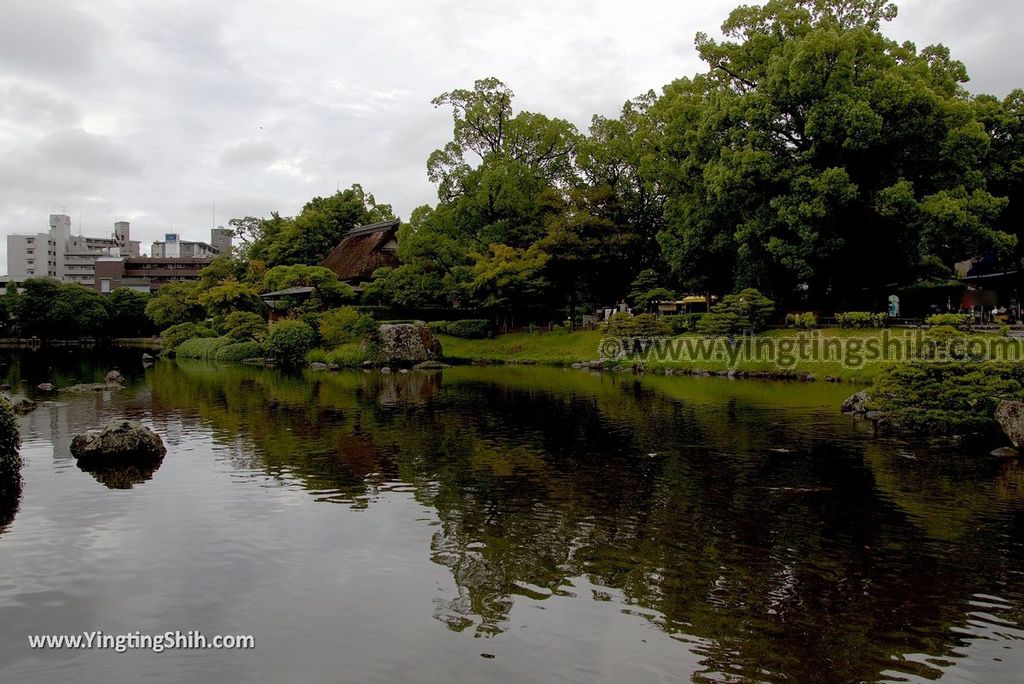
[{"x1": 152, "y1": 364, "x2": 1024, "y2": 681}]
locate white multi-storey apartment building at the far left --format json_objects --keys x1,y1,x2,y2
[{"x1": 7, "y1": 214, "x2": 139, "y2": 287}]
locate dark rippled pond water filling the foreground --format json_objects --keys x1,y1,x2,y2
[{"x1": 0, "y1": 349, "x2": 1024, "y2": 683}]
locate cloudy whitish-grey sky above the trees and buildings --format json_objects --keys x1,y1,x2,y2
[{"x1": 0, "y1": 0, "x2": 1024, "y2": 271}]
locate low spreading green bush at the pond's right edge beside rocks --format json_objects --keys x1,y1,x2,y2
[{"x1": 868, "y1": 360, "x2": 1024, "y2": 434}]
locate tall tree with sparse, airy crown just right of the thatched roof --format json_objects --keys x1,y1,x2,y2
[{"x1": 369, "y1": 78, "x2": 580, "y2": 307}]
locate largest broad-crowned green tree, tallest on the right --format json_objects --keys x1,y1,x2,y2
[{"x1": 650, "y1": 0, "x2": 1015, "y2": 303}]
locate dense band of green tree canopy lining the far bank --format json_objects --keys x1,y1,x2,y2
[{"x1": 203, "y1": 0, "x2": 1024, "y2": 322}]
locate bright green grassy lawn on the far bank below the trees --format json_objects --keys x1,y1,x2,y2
[{"x1": 439, "y1": 329, "x2": 999, "y2": 382}]
